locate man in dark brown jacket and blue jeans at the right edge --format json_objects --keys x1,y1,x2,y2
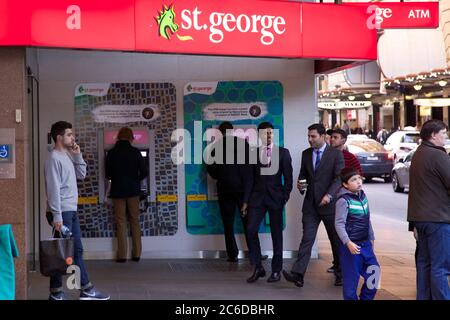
[{"x1": 408, "y1": 120, "x2": 450, "y2": 300}]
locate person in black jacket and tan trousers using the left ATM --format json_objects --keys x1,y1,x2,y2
[{"x1": 105, "y1": 127, "x2": 148, "y2": 262}]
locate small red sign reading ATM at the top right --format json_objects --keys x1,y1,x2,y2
[{"x1": 351, "y1": 2, "x2": 439, "y2": 29}]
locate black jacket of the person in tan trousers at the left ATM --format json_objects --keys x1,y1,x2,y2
[{"x1": 105, "y1": 140, "x2": 148, "y2": 198}]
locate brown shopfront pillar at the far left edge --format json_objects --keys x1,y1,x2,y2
[{"x1": 0, "y1": 48, "x2": 30, "y2": 299}]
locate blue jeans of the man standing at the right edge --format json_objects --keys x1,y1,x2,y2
[{"x1": 414, "y1": 222, "x2": 450, "y2": 300}]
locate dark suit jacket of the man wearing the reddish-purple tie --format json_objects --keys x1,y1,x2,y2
[{"x1": 244, "y1": 146, "x2": 293, "y2": 209}]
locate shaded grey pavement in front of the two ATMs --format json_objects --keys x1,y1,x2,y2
[{"x1": 28, "y1": 257, "x2": 401, "y2": 300}]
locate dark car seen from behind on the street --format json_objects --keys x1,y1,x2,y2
[{"x1": 346, "y1": 137, "x2": 394, "y2": 182}]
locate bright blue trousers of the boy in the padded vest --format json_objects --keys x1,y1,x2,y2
[{"x1": 339, "y1": 241, "x2": 380, "y2": 300}]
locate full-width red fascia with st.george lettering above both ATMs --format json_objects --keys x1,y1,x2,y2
[{"x1": 0, "y1": 0, "x2": 438, "y2": 60}]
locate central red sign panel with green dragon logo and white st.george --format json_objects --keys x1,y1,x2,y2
[{"x1": 136, "y1": 0, "x2": 302, "y2": 57}]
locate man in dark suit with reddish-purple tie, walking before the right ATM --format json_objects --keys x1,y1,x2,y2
[{"x1": 242, "y1": 122, "x2": 292, "y2": 283}]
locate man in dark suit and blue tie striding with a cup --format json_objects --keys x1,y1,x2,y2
[{"x1": 283, "y1": 124, "x2": 344, "y2": 287}]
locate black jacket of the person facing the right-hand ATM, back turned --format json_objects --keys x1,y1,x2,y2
[{"x1": 206, "y1": 136, "x2": 252, "y2": 195}]
